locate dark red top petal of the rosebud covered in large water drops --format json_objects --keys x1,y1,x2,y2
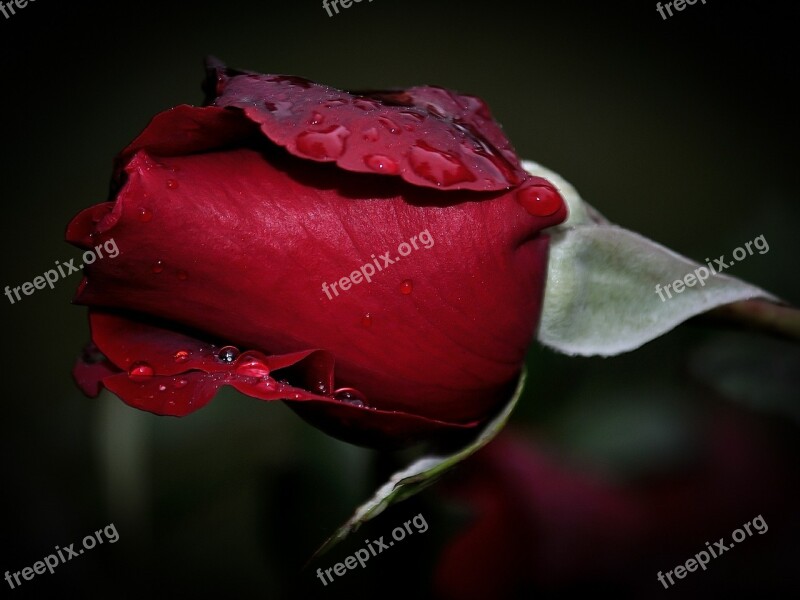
[{"x1": 213, "y1": 68, "x2": 527, "y2": 191}]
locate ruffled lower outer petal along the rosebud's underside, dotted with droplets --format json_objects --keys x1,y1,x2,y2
[{"x1": 75, "y1": 311, "x2": 476, "y2": 447}]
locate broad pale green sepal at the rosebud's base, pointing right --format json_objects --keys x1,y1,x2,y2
[{"x1": 524, "y1": 162, "x2": 778, "y2": 356}]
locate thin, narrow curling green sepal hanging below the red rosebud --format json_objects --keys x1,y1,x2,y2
[{"x1": 309, "y1": 370, "x2": 527, "y2": 562}]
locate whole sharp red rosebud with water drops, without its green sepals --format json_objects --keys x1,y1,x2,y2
[{"x1": 67, "y1": 64, "x2": 567, "y2": 447}]
